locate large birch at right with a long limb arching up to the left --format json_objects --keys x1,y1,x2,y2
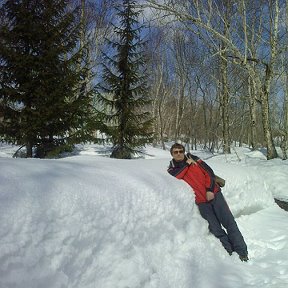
[{"x1": 147, "y1": 0, "x2": 279, "y2": 159}]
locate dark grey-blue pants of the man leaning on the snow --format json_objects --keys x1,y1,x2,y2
[{"x1": 198, "y1": 191, "x2": 247, "y2": 255}]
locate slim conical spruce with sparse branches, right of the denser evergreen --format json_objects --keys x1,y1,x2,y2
[{"x1": 99, "y1": 0, "x2": 152, "y2": 159}]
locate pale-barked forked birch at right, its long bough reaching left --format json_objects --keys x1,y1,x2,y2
[{"x1": 147, "y1": 0, "x2": 279, "y2": 159}]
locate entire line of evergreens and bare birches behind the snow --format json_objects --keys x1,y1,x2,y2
[{"x1": 0, "y1": 0, "x2": 288, "y2": 159}]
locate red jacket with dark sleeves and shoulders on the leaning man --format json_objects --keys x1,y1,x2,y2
[{"x1": 168, "y1": 153, "x2": 221, "y2": 204}]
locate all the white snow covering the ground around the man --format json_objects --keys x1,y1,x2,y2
[{"x1": 0, "y1": 144, "x2": 288, "y2": 288}]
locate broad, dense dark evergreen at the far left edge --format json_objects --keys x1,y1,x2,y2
[{"x1": 0, "y1": 0, "x2": 95, "y2": 157}]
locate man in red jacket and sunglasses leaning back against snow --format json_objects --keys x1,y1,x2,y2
[{"x1": 168, "y1": 143, "x2": 249, "y2": 261}]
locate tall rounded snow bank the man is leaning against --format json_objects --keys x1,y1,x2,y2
[{"x1": 0, "y1": 157, "x2": 193, "y2": 287}]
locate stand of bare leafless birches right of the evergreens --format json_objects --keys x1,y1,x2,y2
[{"x1": 144, "y1": 0, "x2": 288, "y2": 159}]
